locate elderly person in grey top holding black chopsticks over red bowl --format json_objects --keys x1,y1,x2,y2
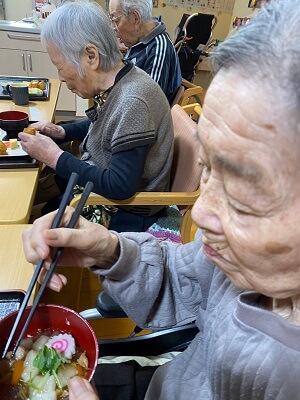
[{"x1": 24, "y1": 0, "x2": 300, "y2": 400}]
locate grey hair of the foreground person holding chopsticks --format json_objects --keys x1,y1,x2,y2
[{"x1": 212, "y1": 0, "x2": 300, "y2": 115}]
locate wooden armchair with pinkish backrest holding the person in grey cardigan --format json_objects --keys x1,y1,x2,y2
[{"x1": 71, "y1": 104, "x2": 202, "y2": 243}]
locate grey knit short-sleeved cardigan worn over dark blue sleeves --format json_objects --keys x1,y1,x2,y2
[{"x1": 82, "y1": 67, "x2": 174, "y2": 192}]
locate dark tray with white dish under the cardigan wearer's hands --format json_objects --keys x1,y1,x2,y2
[{"x1": 0, "y1": 140, "x2": 38, "y2": 169}]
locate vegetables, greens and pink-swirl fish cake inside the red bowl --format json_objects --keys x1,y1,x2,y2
[{"x1": 2, "y1": 331, "x2": 89, "y2": 400}]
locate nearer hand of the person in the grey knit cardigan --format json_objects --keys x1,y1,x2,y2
[{"x1": 19, "y1": 132, "x2": 63, "y2": 170}]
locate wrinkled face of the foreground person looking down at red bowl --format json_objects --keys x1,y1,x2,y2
[{"x1": 193, "y1": 71, "x2": 300, "y2": 298}]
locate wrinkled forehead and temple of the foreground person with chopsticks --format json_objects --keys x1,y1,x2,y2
[{"x1": 198, "y1": 71, "x2": 300, "y2": 180}]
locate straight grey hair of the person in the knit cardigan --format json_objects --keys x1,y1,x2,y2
[{"x1": 41, "y1": 1, "x2": 122, "y2": 77}]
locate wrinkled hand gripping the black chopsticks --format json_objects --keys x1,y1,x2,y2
[{"x1": 23, "y1": 207, "x2": 119, "y2": 292}]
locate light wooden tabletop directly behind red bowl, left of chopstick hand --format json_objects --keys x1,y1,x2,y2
[{"x1": 0, "y1": 225, "x2": 33, "y2": 290}]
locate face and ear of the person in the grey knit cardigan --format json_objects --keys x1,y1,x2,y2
[{"x1": 47, "y1": 46, "x2": 96, "y2": 99}]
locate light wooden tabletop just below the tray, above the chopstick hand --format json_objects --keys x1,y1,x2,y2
[{"x1": 0, "y1": 168, "x2": 39, "y2": 223}]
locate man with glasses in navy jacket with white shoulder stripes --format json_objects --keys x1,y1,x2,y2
[{"x1": 109, "y1": 0, "x2": 182, "y2": 104}]
